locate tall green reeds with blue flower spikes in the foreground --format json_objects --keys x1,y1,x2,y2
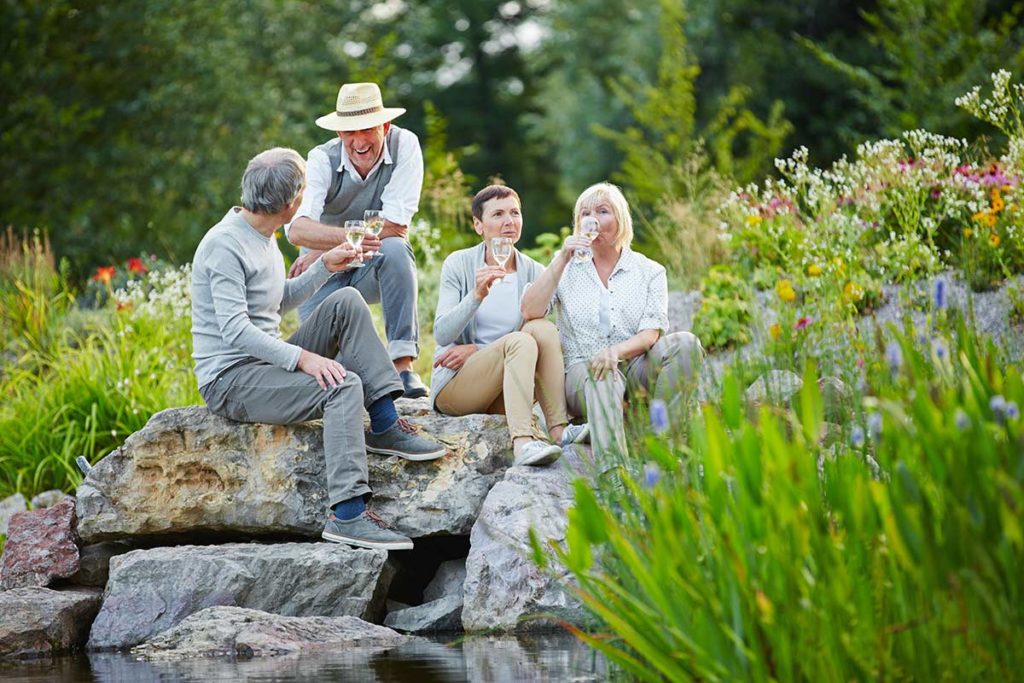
[{"x1": 548, "y1": 325, "x2": 1024, "y2": 681}]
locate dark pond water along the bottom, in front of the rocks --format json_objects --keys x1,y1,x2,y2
[{"x1": 0, "y1": 634, "x2": 607, "y2": 683}]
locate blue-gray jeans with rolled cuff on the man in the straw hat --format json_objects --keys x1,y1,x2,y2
[{"x1": 299, "y1": 238, "x2": 420, "y2": 360}]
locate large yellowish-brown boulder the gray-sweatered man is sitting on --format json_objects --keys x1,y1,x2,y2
[{"x1": 78, "y1": 399, "x2": 511, "y2": 543}]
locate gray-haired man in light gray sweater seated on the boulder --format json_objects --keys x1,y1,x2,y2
[{"x1": 191, "y1": 147, "x2": 444, "y2": 550}]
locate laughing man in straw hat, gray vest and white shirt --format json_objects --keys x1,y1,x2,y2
[{"x1": 285, "y1": 83, "x2": 429, "y2": 398}]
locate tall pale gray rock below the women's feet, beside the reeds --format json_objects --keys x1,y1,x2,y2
[{"x1": 462, "y1": 460, "x2": 586, "y2": 631}]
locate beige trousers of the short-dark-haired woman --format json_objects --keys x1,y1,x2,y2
[{"x1": 434, "y1": 318, "x2": 568, "y2": 439}]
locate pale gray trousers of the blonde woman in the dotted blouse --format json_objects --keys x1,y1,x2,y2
[{"x1": 565, "y1": 332, "x2": 705, "y2": 457}]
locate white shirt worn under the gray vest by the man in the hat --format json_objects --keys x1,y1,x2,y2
[{"x1": 285, "y1": 128, "x2": 423, "y2": 234}]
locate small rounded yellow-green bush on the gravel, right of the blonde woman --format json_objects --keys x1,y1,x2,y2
[{"x1": 693, "y1": 266, "x2": 754, "y2": 349}]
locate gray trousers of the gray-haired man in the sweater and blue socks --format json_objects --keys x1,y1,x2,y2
[{"x1": 200, "y1": 288, "x2": 402, "y2": 506}]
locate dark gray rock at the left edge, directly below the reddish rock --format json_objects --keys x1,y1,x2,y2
[{"x1": 0, "y1": 588, "x2": 99, "y2": 657}]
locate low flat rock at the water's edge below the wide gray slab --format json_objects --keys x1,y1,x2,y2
[{"x1": 132, "y1": 607, "x2": 409, "y2": 659}]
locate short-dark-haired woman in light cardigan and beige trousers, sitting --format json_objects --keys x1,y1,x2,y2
[{"x1": 430, "y1": 185, "x2": 589, "y2": 465}]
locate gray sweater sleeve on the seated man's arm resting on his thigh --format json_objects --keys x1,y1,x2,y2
[{"x1": 210, "y1": 246, "x2": 302, "y2": 371}]
